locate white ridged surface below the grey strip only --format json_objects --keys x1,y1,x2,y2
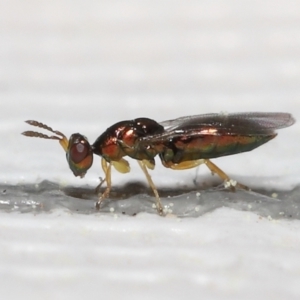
[{"x1": 0, "y1": 209, "x2": 300, "y2": 299}]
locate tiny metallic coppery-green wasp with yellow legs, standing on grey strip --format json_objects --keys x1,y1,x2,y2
[{"x1": 23, "y1": 112, "x2": 295, "y2": 215}]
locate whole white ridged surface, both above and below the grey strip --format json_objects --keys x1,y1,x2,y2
[{"x1": 0, "y1": 0, "x2": 300, "y2": 299}]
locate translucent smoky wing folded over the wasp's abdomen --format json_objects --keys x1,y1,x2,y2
[{"x1": 140, "y1": 112, "x2": 295, "y2": 145}]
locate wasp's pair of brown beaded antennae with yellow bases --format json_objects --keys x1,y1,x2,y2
[{"x1": 22, "y1": 120, "x2": 69, "y2": 152}]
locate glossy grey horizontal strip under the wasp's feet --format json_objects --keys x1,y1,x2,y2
[{"x1": 0, "y1": 181, "x2": 300, "y2": 219}]
